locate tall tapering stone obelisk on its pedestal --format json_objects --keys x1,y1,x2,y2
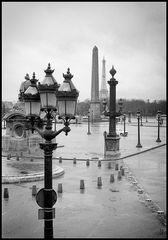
[{"x1": 90, "y1": 46, "x2": 100, "y2": 121}]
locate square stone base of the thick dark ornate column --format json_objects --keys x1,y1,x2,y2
[{"x1": 104, "y1": 132, "x2": 120, "y2": 157}]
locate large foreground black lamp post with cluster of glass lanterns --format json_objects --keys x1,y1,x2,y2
[{"x1": 19, "y1": 63, "x2": 79, "y2": 238}]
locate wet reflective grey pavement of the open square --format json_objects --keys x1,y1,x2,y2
[{"x1": 2, "y1": 119, "x2": 166, "y2": 238}]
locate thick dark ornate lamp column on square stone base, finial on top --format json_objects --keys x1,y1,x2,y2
[{"x1": 103, "y1": 66, "x2": 120, "y2": 155}]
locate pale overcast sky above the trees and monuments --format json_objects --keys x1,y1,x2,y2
[{"x1": 2, "y1": 2, "x2": 166, "y2": 101}]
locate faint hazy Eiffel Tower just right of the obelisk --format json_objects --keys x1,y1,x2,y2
[{"x1": 100, "y1": 58, "x2": 108, "y2": 99}]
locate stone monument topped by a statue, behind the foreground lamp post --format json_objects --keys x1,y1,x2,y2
[{"x1": 2, "y1": 74, "x2": 43, "y2": 154}]
